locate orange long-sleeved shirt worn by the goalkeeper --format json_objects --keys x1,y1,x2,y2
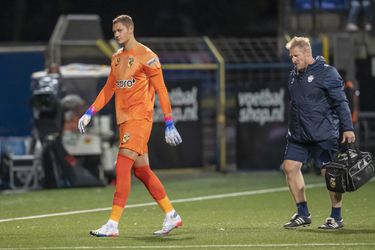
[{"x1": 91, "y1": 43, "x2": 172, "y2": 124}]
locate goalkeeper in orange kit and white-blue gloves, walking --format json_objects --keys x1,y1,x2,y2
[{"x1": 78, "y1": 15, "x2": 182, "y2": 237}]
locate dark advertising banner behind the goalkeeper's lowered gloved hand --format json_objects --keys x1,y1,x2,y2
[{"x1": 149, "y1": 80, "x2": 203, "y2": 168}]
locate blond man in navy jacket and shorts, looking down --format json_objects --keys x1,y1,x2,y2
[{"x1": 283, "y1": 37, "x2": 355, "y2": 229}]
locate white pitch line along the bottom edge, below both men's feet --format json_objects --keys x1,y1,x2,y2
[{"x1": 0, "y1": 242, "x2": 375, "y2": 250}]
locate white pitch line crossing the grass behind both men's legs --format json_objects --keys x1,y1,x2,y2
[{"x1": 0, "y1": 183, "x2": 325, "y2": 223}]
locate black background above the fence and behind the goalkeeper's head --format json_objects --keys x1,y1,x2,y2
[{"x1": 0, "y1": 0, "x2": 277, "y2": 43}]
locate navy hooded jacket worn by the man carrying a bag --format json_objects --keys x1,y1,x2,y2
[{"x1": 287, "y1": 56, "x2": 353, "y2": 143}]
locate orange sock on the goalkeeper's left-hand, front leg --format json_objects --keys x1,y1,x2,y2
[{"x1": 110, "y1": 154, "x2": 134, "y2": 222}]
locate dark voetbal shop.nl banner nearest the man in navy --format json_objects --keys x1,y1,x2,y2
[{"x1": 237, "y1": 81, "x2": 287, "y2": 169}]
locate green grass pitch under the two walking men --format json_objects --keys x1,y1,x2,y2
[{"x1": 0, "y1": 172, "x2": 375, "y2": 249}]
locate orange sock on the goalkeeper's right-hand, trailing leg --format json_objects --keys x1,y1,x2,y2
[{"x1": 134, "y1": 166, "x2": 173, "y2": 213}]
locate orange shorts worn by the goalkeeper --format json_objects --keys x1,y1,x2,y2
[{"x1": 119, "y1": 119, "x2": 152, "y2": 155}]
